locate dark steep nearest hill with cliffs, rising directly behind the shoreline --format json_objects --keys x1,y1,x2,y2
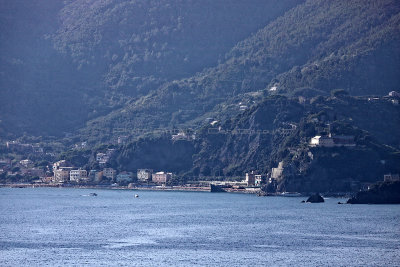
[{"x1": 113, "y1": 96, "x2": 400, "y2": 192}]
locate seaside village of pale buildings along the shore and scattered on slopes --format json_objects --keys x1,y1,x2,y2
[{"x1": 0, "y1": 92, "x2": 400, "y2": 193}]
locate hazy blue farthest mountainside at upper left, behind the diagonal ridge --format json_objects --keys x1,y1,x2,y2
[{"x1": 0, "y1": 0, "x2": 301, "y2": 138}]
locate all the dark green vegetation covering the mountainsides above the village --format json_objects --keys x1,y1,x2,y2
[{"x1": 0, "y1": 0, "x2": 400, "y2": 191}]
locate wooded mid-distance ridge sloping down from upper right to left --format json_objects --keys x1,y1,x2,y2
[{"x1": 77, "y1": 0, "x2": 400, "y2": 144}]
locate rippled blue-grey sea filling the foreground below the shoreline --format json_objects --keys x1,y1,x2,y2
[{"x1": 0, "y1": 188, "x2": 400, "y2": 266}]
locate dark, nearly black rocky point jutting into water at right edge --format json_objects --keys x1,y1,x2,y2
[{"x1": 347, "y1": 181, "x2": 400, "y2": 204}]
